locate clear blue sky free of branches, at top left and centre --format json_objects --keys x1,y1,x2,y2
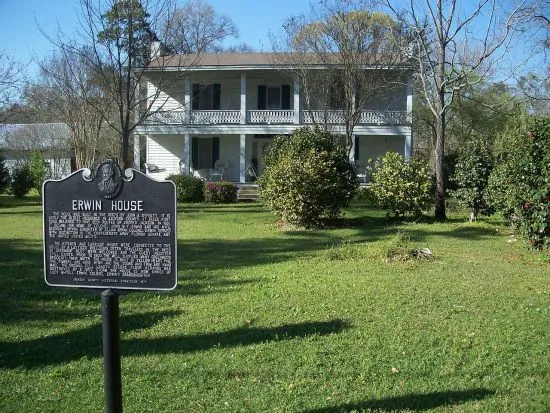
[{"x1": 0, "y1": 0, "x2": 309, "y2": 78}]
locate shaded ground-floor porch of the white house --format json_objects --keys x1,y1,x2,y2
[{"x1": 140, "y1": 133, "x2": 411, "y2": 184}]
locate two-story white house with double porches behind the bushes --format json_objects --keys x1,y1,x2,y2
[{"x1": 134, "y1": 53, "x2": 412, "y2": 183}]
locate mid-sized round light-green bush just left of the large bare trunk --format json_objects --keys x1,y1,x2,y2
[{"x1": 368, "y1": 151, "x2": 433, "y2": 217}]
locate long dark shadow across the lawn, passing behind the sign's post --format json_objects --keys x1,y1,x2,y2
[{"x1": 0, "y1": 312, "x2": 349, "y2": 369}]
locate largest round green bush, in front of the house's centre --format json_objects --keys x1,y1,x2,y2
[{"x1": 258, "y1": 128, "x2": 358, "y2": 227}]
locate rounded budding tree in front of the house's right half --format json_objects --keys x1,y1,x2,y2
[{"x1": 274, "y1": 1, "x2": 407, "y2": 151}]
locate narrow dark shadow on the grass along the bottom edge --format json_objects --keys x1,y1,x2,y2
[{"x1": 302, "y1": 389, "x2": 495, "y2": 413}]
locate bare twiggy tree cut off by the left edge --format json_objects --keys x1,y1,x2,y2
[{"x1": 0, "y1": 50, "x2": 25, "y2": 123}]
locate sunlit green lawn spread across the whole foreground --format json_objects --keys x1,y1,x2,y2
[{"x1": 0, "y1": 196, "x2": 550, "y2": 413}]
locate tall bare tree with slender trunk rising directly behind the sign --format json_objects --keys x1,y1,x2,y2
[{"x1": 44, "y1": 0, "x2": 197, "y2": 168}]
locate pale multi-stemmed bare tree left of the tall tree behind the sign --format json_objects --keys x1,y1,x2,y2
[{"x1": 25, "y1": 50, "x2": 120, "y2": 168}]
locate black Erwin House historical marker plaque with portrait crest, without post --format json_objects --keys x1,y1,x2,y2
[{"x1": 42, "y1": 160, "x2": 177, "y2": 290}]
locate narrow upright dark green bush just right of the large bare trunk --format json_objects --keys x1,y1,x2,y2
[{"x1": 449, "y1": 135, "x2": 494, "y2": 221}]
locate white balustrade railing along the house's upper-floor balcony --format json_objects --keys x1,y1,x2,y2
[{"x1": 145, "y1": 110, "x2": 411, "y2": 125}]
